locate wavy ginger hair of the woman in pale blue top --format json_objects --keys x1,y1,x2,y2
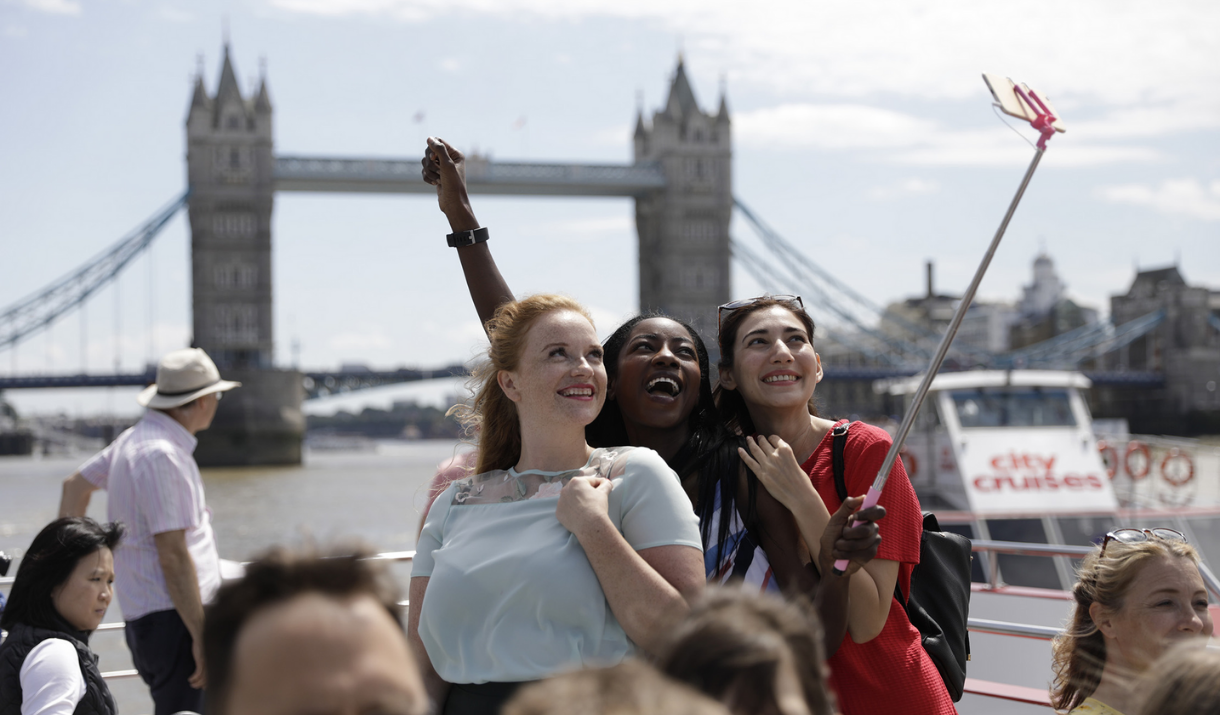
[{"x1": 451, "y1": 294, "x2": 593, "y2": 473}]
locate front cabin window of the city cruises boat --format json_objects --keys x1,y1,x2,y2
[{"x1": 950, "y1": 387, "x2": 1076, "y2": 429}]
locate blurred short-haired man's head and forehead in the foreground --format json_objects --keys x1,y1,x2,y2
[{"x1": 204, "y1": 549, "x2": 427, "y2": 715}]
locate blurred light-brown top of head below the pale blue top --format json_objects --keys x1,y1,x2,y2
[{"x1": 501, "y1": 660, "x2": 728, "y2": 715}]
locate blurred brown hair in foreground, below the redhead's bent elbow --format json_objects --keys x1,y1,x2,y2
[{"x1": 658, "y1": 588, "x2": 834, "y2": 715}]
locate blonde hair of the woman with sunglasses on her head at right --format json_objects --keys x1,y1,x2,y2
[{"x1": 1050, "y1": 537, "x2": 1199, "y2": 711}]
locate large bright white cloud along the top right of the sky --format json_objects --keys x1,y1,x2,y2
[{"x1": 272, "y1": 0, "x2": 1220, "y2": 119}]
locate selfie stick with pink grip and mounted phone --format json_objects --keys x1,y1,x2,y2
[{"x1": 834, "y1": 74, "x2": 1065, "y2": 575}]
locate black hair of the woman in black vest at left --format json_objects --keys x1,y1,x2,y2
[{"x1": 0, "y1": 516, "x2": 123, "y2": 630}]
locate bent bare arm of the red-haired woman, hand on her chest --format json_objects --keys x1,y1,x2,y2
[{"x1": 555, "y1": 477, "x2": 705, "y2": 653}]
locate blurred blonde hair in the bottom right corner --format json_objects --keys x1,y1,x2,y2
[{"x1": 1135, "y1": 643, "x2": 1220, "y2": 715}]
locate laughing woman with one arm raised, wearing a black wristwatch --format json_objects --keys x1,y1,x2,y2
[{"x1": 421, "y1": 138, "x2": 885, "y2": 652}]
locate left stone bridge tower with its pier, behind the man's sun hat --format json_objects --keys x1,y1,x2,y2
[{"x1": 187, "y1": 43, "x2": 304, "y2": 465}]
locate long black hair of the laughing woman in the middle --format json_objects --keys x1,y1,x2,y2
[{"x1": 584, "y1": 312, "x2": 758, "y2": 571}]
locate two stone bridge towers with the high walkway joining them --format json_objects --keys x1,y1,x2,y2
[{"x1": 178, "y1": 45, "x2": 733, "y2": 464}]
